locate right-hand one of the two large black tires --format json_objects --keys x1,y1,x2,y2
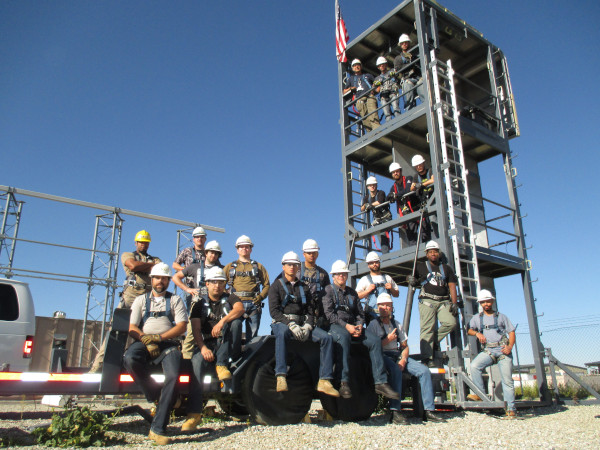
[{"x1": 319, "y1": 345, "x2": 377, "y2": 422}]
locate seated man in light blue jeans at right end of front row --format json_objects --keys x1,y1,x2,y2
[{"x1": 367, "y1": 293, "x2": 444, "y2": 425}]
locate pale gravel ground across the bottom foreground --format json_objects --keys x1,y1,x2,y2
[{"x1": 0, "y1": 399, "x2": 600, "y2": 449}]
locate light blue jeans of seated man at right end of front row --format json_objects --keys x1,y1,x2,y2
[{"x1": 383, "y1": 351, "x2": 435, "y2": 411}]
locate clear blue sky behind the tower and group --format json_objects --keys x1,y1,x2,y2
[{"x1": 0, "y1": 0, "x2": 600, "y2": 366}]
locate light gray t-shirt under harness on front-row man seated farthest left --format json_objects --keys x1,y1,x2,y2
[{"x1": 129, "y1": 294, "x2": 188, "y2": 334}]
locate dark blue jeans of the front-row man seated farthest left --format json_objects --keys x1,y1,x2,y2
[{"x1": 123, "y1": 341, "x2": 182, "y2": 435}]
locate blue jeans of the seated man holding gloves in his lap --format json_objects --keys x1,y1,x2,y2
[{"x1": 271, "y1": 322, "x2": 333, "y2": 380}]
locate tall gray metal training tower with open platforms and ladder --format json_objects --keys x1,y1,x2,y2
[{"x1": 338, "y1": 0, "x2": 548, "y2": 407}]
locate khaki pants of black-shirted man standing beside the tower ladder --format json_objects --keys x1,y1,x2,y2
[{"x1": 419, "y1": 298, "x2": 458, "y2": 360}]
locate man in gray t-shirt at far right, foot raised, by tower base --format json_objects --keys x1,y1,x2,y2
[{"x1": 467, "y1": 289, "x2": 517, "y2": 419}]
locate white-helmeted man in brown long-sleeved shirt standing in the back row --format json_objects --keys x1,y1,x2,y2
[{"x1": 225, "y1": 235, "x2": 270, "y2": 342}]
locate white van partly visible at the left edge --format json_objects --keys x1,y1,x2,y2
[{"x1": 0, "y1": 278, "x2": 35, "y2": 372}]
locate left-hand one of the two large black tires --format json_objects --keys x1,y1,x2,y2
[{"x1": 242, "y1": 353, "x2": 314, "y2": 425}]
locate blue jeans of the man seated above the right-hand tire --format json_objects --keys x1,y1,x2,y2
[{"x1": 329, "y1": 323, "x2": 387, "y2": 384}]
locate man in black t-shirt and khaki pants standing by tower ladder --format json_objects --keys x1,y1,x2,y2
[{"x1": 407, "y1": 241, "x2": 458, "y2": 367}]
